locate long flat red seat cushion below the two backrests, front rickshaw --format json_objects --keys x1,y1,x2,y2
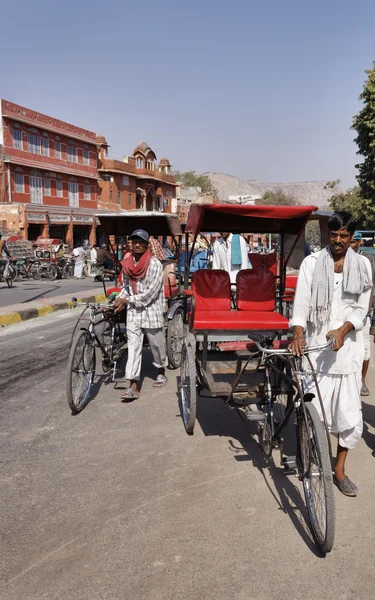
[{"x1": 193, "y1": 310, "x2": 289, "y2": 331}]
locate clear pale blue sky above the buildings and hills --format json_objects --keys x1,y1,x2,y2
[{"x1": 0, "y1": 0, "x2": 375, "y2": 187}]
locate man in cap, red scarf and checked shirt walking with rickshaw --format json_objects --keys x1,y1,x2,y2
[{"x1": 116, "y1": 229, "x2": 167, "y2": 400}]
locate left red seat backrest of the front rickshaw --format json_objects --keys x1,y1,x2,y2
[{"x1": 191, "y1": 269, "x2": 231, "y2": 312}]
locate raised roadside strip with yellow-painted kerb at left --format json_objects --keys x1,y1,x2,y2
[{"x1": 0, "y1": 290, "x2": 106, "y2": 327}]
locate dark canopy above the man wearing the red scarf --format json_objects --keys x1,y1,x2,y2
[{"x1": 96, "y1": 210, "x2": 182, "y2": 236}]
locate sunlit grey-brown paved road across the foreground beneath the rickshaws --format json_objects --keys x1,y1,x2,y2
[{"x1": 0, "y1": 312, "x2": 375, "y2": 600}]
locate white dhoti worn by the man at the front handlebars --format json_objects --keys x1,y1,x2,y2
[{"x1": 304, "y1": 371, "x2": 363, "y2": 449}]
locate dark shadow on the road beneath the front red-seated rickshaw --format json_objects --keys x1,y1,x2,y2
[{"x1": 197, "y1": 397, "x2": 324, "y2": 558}]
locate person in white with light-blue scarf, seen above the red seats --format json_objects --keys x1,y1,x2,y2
[{"x1": 212, "y1": 232, "x2": 251, "y2": 284}]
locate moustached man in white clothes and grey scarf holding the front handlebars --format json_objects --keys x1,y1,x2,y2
[{"x1": 290, "y1": 211, "x2": 372, "y2": 496}]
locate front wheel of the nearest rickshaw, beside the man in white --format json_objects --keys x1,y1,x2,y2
[{"x1": 299, "y1": 402, "x2": 335, "y2": 553}]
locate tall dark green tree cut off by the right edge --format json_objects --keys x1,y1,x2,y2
[{"x1": 352, "y1": 62, "x2": 375, "y2": 202}]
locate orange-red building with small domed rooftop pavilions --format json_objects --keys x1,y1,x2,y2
[{"x1": 96, "y1": 135, "x2": 177, "y2": 213}]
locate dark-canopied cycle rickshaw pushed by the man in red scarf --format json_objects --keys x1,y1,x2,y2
[{"x1": 66, "y1": 211, "x2": 184, "y2": 414}]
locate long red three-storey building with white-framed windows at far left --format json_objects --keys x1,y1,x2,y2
[{"x1": 0, "y1": 100, "x2": 98, "y2": 244}]
